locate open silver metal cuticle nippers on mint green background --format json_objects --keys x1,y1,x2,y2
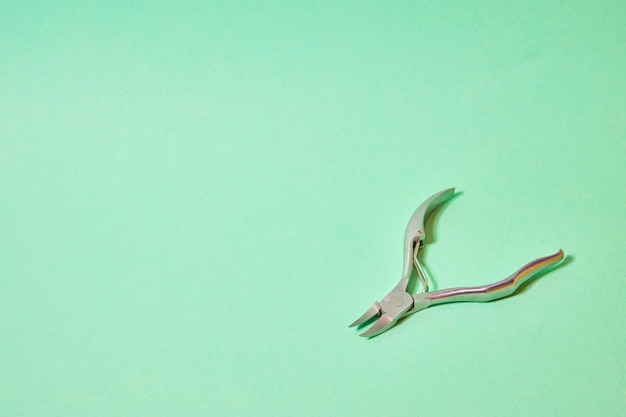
[{"x1": 350, "y1": 188, "x2": 564, "y2": 337}]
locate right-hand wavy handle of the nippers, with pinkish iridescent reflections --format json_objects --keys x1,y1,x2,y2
[{"x1": 420, "y1": 250, "x2": 565, "y2": 308}]
